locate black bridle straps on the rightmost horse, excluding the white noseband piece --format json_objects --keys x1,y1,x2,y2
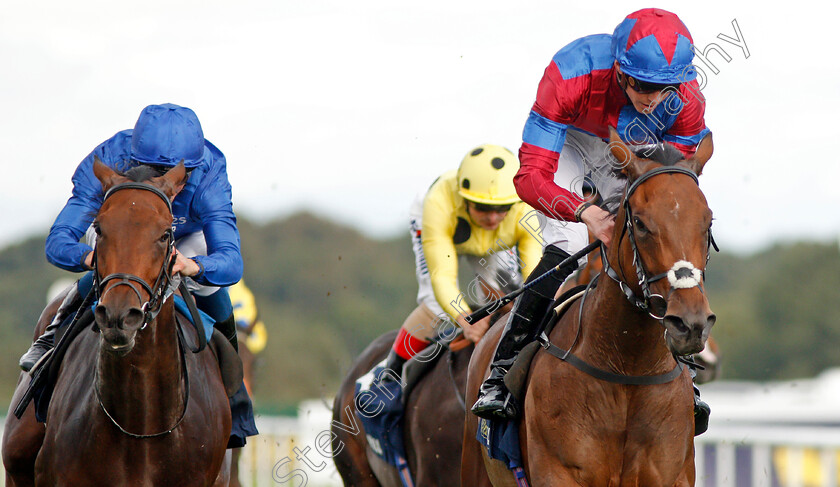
[{"x1": 601, "y1": 166, "x2": 718, "y2": 321}]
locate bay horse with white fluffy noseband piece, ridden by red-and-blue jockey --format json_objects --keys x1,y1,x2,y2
[{"x1": 462, "y1": 131, "x2": 715, "y2": 487}]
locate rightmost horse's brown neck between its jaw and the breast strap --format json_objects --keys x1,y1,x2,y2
[{"x1": 573, "y1": 276, "x2": 674, "y2": 375}]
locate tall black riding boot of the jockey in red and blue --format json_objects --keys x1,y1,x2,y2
[{"x1": 472, "y1": 245, "x2": 577, "y2": 419}]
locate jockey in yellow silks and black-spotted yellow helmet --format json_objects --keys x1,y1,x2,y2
[{"x1": 384, "y1": 144, "x2": 542, "y2": 377}]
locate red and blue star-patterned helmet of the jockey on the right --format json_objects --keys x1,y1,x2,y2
[{"x1": 612, "y1": 8, "x2": 697, "y2": 85}]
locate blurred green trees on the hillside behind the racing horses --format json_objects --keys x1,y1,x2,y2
[{"x1": 0, "y1": 213, "x2": 840, "y2": 412}]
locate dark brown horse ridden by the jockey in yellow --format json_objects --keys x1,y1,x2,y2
[{"x1": 332, "y1": 331, "x2": 474, "y2": 487}]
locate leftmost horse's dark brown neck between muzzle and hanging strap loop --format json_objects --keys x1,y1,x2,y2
[{"x1": 96, "y1": 299, "x2": 185, "y2": 433}]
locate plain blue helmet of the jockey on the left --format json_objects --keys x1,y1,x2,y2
[{"x1": 131, "y1": 103, "x2": 204, "y2": 168}]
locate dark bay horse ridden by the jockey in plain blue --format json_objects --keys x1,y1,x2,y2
[{"x1": 3, "y1": 160, "x2": 231, "y2": 486}]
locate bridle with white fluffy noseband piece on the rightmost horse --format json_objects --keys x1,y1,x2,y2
[{"x1": 601, "y1": 166, "x2": 718, "y2": 321}]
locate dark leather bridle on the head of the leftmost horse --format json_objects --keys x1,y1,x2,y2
[{"x1": 92, "y1": 183, "x2": 175, "y2": 330}]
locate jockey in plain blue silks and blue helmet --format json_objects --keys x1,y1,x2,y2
[{"x1": 20, "y1": 104, "x2": 257, "y2": 447}]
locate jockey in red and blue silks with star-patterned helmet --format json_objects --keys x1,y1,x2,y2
[{"x1": 472, "y1": 9, "x2": 709, "y2": 430}]
